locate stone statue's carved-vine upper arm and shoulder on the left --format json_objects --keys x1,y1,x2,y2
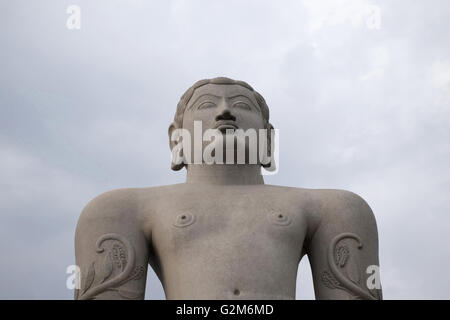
[{"x1": 75, "y1": 189, "x2": 149, "y2": 300}]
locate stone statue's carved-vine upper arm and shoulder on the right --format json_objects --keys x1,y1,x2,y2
[{"x1": 306, "y1": 190, "x2": 382, "y2": 300}]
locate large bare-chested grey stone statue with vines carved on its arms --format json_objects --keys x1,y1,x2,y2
[{"x1": 75, "y1": 78, "x2": 381, "y2": 299}]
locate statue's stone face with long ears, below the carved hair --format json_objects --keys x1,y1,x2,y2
[{"x1": 169, "y1": 83, "x2": 273, "y2": 170}]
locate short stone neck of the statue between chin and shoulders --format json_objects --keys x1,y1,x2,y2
[{"x1": 186, "y1": 164, "x2": 264, "y2": 185}]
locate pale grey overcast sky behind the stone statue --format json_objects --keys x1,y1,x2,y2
[{"x1": 0, "y1": 0, "x2": 450, "y2": 299}]
